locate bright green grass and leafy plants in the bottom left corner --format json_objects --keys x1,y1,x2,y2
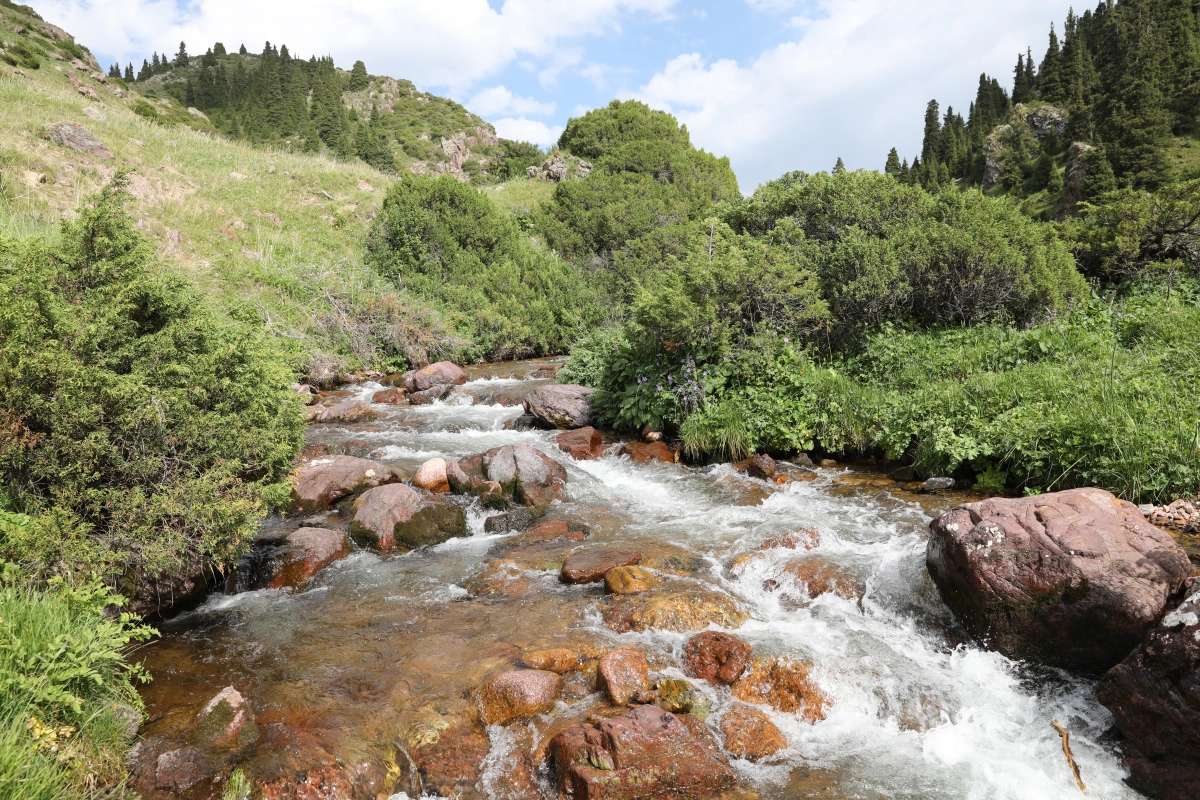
[{"x1": 0, "y1": 566, "x2": 152, "y2": 800}]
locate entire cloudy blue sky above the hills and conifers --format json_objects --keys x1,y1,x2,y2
[{"x1": 32, "y1": 0, "x2": 1082, "y2": 192}]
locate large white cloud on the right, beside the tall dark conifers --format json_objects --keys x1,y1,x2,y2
[{"x1": 634, "y1": 0, "x2": 1070, "y2": 191}]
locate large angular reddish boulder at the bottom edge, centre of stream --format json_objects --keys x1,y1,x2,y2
[{"x1": 550, "y1": 705, "x2": 737, "y2": 800}]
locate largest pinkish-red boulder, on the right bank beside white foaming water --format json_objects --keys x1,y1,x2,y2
[{"x1": 925, "y1": 488, "x2": 1192, "y2": 673}]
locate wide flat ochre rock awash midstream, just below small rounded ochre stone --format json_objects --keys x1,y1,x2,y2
[{"x1": 600, "y1": 588, "x2": 749, "y2": 633}]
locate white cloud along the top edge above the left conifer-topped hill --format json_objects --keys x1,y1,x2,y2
[{"x1": 36, "y1": 0, "x2": 678, "y2": 92}]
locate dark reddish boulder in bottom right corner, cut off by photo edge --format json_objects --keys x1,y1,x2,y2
[{"x1": 1097, "y1": 578, "x2": 1200, "y2": 800}]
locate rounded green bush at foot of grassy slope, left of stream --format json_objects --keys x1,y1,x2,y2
[{"x1": 367, "y1": 175, "x2": 602, "y2": 359}]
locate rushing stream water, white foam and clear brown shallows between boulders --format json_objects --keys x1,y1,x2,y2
[{"x1": 136, "y1": 367, "x2": 1139, "y2": 800}]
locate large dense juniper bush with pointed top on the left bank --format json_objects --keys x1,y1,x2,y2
[{"x1": 0, "y1": 178, "x2": 304, "y2": 591}]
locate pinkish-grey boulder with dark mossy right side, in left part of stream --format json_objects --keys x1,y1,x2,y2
[{"x1": 350, "y1": 483, "x2": 467, "y2": 552}]
